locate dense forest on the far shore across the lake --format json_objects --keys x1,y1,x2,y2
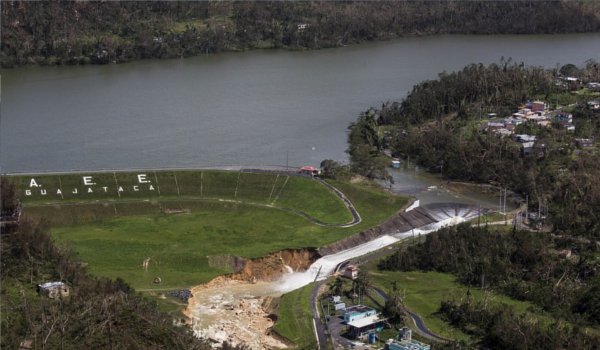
[{"x1": 0, "y1": 0, "x2": 600, "y2": 67}]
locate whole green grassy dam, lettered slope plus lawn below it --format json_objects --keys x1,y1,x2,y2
[{"x1": 11, "y1": 171, "x2": 407, "y2": 290}]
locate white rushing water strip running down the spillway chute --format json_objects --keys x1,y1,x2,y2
[{"x1": 275, "y1": 216, "x2": 465, "y2": 293}]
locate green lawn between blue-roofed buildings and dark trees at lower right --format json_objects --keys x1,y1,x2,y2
[{"x1": 367, "y1": 263, "x2": 543, "y2": 341}]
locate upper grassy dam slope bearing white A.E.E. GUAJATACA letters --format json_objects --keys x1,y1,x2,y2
[{"x1": 11, "y1": 171, "x2": 352, "y2": 225}]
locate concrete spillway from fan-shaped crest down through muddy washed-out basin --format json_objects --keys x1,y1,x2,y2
[{"x1": 188, "y1": 203, "x2": 486, "y2": 349}]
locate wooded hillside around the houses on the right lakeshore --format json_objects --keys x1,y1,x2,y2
[{"x1": 344, "y1": 59, "x2": 600, "y2": 239}]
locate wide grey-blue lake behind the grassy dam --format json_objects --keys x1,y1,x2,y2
[{"x1": 0, "y1": 34, "x2": 600, "y2": 173}]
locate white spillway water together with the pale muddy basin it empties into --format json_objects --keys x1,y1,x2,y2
[{"x1": 190, "y1": 213, "x2": 466, "y2": 349}]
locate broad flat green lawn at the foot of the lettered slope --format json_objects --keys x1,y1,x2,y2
[{"x1": 52, "y1": 202, "x2": 345, "y2": 289}]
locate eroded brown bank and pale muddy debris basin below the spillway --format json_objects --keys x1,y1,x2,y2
[{"x1": 184, "y1": 249, "x2": 320, "y2": 350}]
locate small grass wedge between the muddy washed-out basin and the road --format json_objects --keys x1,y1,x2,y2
[{"x1": 274, "y1": 283, "x2": 317, "y2": 349}]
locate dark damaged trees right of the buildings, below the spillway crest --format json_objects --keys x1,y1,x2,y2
[{"x1": 379, "y1": 224, "x2": 600, "y2": 349}]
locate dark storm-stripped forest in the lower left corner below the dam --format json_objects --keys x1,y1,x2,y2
[{"x1": 0, "y1": 179, "x2": 244, "y2": 349}]
